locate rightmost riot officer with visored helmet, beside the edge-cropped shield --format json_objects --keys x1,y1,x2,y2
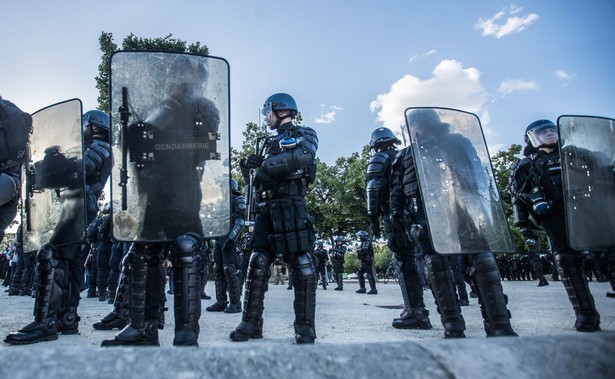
[{"x1": 510, "y1": 120, "x2": 600, "y2": 332}]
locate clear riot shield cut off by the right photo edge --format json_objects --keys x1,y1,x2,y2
[{"x1": 557, "y1": 116, "x2": 615, "y2": 251}]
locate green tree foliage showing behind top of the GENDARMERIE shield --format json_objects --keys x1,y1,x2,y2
[{"x1": 95, "y1": 31, "x2": 209, "y2": 111}]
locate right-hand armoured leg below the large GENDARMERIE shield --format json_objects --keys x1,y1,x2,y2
[{"x1": 171, "y1": 233, "x2": 201, "y2": 346}]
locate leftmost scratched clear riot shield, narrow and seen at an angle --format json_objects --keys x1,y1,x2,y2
[{"x1": 21, "y1": 99, "x2": 86, "y2": 251}]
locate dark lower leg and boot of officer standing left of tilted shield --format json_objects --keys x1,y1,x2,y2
[{"x1": 392, "y1": 256, "x2": 432, "y2": 329}]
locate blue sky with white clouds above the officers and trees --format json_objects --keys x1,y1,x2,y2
[{"x1": 0, "y1": 0, "x2": 615, "y2": 163}]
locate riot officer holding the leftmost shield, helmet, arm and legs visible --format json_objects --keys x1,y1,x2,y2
[{"x1": 5, "y1": 110, "x2": 112, "y2": 345}]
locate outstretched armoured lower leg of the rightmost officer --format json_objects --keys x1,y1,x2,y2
[{"x1": 554, "y1": 251, "x2": 600, "y2": 332}]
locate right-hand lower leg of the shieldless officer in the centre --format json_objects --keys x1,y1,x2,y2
[{"x1": 291, "y1": 253, "x2": 317, "y2": 343}]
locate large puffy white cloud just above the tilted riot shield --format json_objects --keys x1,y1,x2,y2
[{"x1": 369, "y1": 60, "x2": 489, "y2": 130}]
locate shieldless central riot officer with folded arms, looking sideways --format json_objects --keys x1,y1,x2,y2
[{"x1": 230, "y1": 93, "x2": 318, "y2": 344}]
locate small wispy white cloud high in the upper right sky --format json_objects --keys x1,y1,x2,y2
[{"x1": 474, "y1": 5, "x2": 540, "y2": 39}]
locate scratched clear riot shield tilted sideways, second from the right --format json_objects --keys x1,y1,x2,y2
[{"x1": 405, "y1": 108, "x2": 514, "y2": 254}]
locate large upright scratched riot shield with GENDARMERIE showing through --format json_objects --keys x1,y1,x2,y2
[{"x1": 111, "y1": 51, "x2": 231, "y2": 242}]
